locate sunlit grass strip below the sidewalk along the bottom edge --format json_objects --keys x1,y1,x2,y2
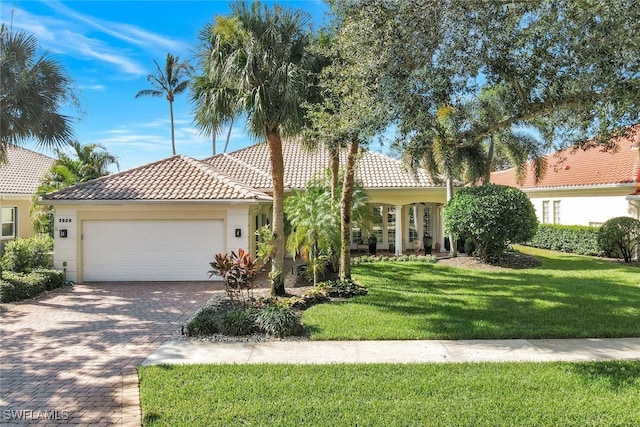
[{"x1": 139, "y1": 362, "x2": 640, "y2": 427}]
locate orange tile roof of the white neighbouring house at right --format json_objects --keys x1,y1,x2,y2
[{"x1": 491, "y1": 132, "x2": 640, "y2": 189}]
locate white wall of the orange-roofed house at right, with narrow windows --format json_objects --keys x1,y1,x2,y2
[{"x1": 527, "y1": 186, "x2": 638, "y2": 226}]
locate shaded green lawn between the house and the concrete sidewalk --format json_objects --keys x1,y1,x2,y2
[{"x1": 302, "y1": 247, "x2": 640, "y2": 340}]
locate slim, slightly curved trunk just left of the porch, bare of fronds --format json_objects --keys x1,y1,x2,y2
[{"x1": 340, "y1": 138, "x2": 360, "y2": 280}]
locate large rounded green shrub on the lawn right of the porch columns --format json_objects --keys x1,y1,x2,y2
[{"x1": 444, "y1": 184, "x2": 538, "y2": 260}]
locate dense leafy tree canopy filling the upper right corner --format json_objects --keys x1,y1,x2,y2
[{"x1": 372, "y1": 0, "x2": 640, "y2": 153}]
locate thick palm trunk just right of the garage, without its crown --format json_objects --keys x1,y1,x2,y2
[{"x1": 267, "y1": 129, "x2": 285, "y2": 296}]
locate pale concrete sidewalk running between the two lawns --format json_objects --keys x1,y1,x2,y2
[{"x1": 143, "y1": 338, "x2": 640, "y2": 365}]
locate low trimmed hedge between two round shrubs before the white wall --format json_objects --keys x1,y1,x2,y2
[{"x1": 527, "y1": 224, "x2": 604, "y2": 256}]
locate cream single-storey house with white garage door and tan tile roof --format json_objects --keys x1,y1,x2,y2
[{"x1": 43, "y1": 142, "x2": 446, "y2": 281}]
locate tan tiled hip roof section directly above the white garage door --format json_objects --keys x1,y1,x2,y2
[{"x1": 43, "y1": 155, "x2": 271, "y2": 201}]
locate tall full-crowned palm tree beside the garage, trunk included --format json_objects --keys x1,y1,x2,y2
[{"x1": 191, "y1": 2, "x2": 316, "y2": 295}]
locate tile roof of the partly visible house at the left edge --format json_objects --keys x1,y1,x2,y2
[{"x1": 0, "y1": 145, "x2": 55, "y2": 194}]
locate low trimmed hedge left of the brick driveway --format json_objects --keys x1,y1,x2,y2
[{"x1": 0, "y1": 269, "x2": 64, "y2": 302}]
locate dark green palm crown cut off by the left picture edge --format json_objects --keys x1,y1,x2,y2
[{"x1": 0, "y1": 24, "x2": 75, "y2": 162}]
